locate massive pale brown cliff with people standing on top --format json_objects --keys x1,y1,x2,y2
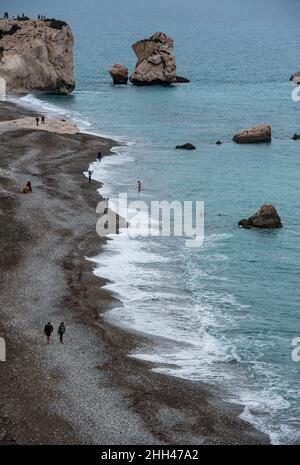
[{"x1": 0, "y1": 19, "x2": 75, "y2": 94}]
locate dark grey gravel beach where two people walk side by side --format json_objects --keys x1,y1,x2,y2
[{"x1": 0, "y1": 103, "x2": 269, "y2": 445}]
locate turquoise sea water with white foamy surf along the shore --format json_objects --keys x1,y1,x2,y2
[{"x1": 1, "y1": 0, "x2": 300, "y2": 443}]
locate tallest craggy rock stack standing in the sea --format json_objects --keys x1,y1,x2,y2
[{"x1": 130, "y1": 32, "x2": 176, "y2": 86}]
